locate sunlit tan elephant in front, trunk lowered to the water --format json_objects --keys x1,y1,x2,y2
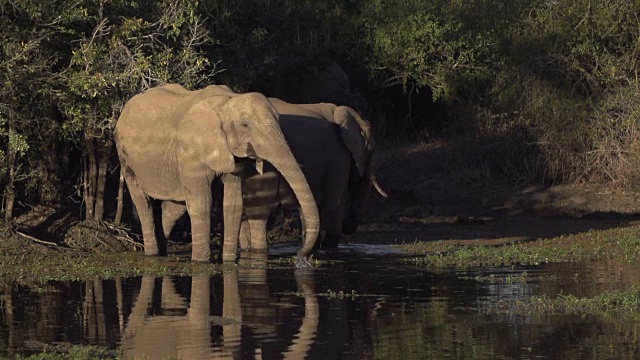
[{"x1": 115, "y1": 84, "x2": 319, "y2": 263}]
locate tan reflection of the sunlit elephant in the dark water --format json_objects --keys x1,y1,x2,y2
[{"x1": 122, "y1": 253, "x2": 319, "y2": 359}]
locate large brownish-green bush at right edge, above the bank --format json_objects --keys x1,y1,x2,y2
[{"x1": 495, "y1": 0, "x2": 640, "y2": 183}]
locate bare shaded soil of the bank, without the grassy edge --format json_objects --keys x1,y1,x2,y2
[{"x1": 0, "y1": 141, "x2": 640, "y2": 251}]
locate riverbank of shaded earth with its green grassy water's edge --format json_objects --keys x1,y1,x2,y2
[{"x1": 0, "y1": 142, "x2": 640, "y2": 283}]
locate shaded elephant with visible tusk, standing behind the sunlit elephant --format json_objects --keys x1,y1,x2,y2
[{"x1": 234, "y1": 98, "x2": 386, "y2": 251}]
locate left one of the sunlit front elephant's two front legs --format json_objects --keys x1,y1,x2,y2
[{"x1": 185, "y1": 180, "x2": 211, "y2": 261}]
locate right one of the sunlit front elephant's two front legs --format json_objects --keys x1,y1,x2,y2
[{"x1": 222, "y1": 174, "x2": 242, "y2": 261}]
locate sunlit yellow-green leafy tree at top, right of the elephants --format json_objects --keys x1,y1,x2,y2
[{"x1": 358, "y1": 0, "x2": 499, "y2": 101}]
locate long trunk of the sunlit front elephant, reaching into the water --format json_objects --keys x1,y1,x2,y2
[{"x1": 263, "y1": 128, "x2": 320, "y2": 266}]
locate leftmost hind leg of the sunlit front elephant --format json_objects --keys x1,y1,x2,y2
[{"x1": 125, "y1": 172, "x2": 160, "y2": 256}]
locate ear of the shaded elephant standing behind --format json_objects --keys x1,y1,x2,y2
[{"x1": 333, "y1": 106, "x2": 374, "y2": 176}]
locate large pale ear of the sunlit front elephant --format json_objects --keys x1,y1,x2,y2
[{"x1": 177, "y1": 96, "x2": 235, "y2": 173}]
